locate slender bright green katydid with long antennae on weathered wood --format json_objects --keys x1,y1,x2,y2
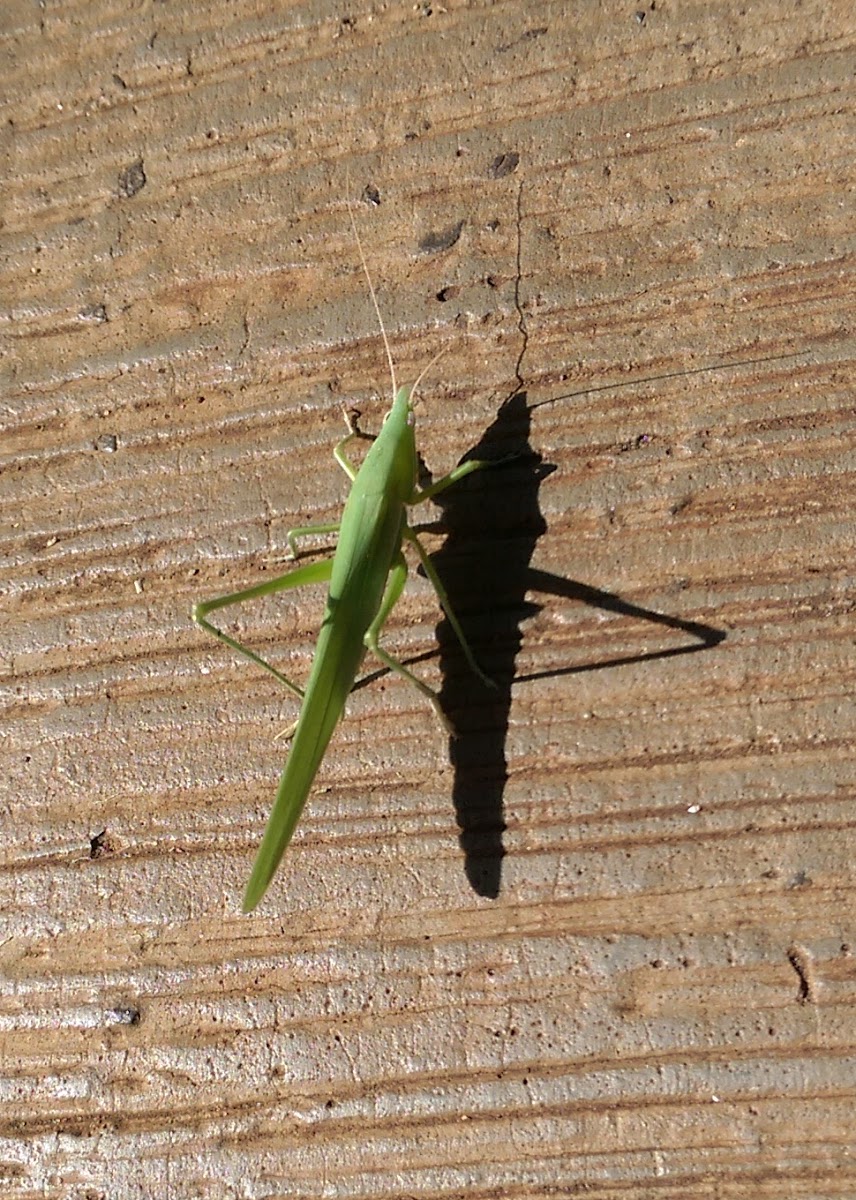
[{"x1": 192, "y1": 196, "x2": 493, "y2": 912}]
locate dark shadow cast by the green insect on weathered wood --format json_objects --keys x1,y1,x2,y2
[{"x1": 419, "y1": 391, "x2": 725, "y2": 899}]
